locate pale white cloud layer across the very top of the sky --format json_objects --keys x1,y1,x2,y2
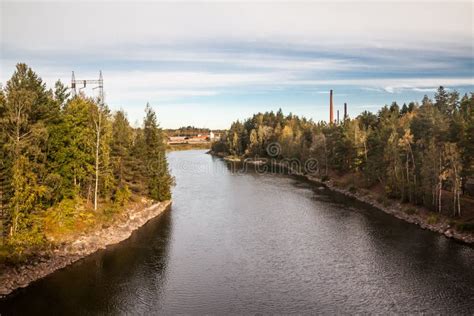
[{"x1": 1, "y1": 1, "x2": 473, "y2": 54}]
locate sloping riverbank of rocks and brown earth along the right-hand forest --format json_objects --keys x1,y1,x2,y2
[{"x1": 208, "y1": 151, "x2": 474, "y2": 245}]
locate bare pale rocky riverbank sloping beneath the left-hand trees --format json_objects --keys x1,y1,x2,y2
[{"x1": 0, "y1": 201, "x2": 171, "y2": 297}]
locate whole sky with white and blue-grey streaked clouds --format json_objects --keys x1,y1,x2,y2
[{"x1": 0, "y1": 0, "x2": 474, "y2": 129}]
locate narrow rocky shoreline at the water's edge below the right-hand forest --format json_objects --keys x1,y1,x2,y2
[{"x1": 208, "y1": 151, "x2": 474, "y2": 245}]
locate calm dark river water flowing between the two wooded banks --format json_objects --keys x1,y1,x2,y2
[{"x1": 0, "y1": 151, "x2": 474, "y2": 315}]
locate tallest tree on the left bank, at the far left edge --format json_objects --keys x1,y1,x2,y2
[{"x1": 2, "y1": 64, "x2": 52, "y2": 242}]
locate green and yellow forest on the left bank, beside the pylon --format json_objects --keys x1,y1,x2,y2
[{"x1": 0, "y1": 63, "x2": 173, "y2": 258}]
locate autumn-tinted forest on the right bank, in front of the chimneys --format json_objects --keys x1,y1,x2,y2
[{"x1": 212, "y1": 87, "x2": 474, "y2": 222}]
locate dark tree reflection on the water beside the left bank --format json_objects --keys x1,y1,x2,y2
[{"x1": 0, "y1": 211, "x2": 172, "y2": 315}]
